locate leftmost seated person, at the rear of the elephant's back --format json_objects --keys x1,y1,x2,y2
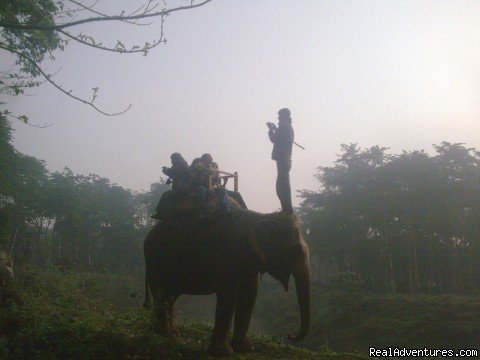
[{"x1": 152, "y1": 153, "x2": 191, "y2": 219}]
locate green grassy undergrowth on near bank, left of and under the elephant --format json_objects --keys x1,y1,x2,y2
[{"x1": 0, "y1": 267, "x2": 361, "y2": 359}]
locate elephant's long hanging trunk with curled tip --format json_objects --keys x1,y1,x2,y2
[{"x1": 287, "y1": 261, "x2": 311, "y2": 342}]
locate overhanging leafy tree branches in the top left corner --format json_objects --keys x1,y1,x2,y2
[{"x1": 0, "y1": 0, "x2": 211, "y2": 121}]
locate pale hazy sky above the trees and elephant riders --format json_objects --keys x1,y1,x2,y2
[{"x1": 2, "y1": 0, "x2": 480, "y2": 211}]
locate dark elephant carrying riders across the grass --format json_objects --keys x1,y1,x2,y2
[{"x1": 144, "y1": 209, "x2": 310, "y2": 356}]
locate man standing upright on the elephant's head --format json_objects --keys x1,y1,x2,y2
[{"x1": 267, "y1": 108, "x2": 294, "y2": 214}]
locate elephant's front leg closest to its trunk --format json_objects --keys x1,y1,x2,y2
[{"x1": 232, "y1": 276, "x2": 258, "y2": 352}]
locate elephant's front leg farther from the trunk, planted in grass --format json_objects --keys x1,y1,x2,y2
[{"x1": 207, "y1": 286, "x2": 238, "y2": 356}]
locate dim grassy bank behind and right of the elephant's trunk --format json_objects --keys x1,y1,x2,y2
[{"x1": 257, "y1": 278, "x2": 480, "y2": 355}]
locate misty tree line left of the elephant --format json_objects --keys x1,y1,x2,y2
[{"x1": 0, "y1": 116, "x2": 169, "y2": 272}]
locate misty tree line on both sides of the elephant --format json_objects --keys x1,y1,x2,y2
[{"x1": 0, "y1": 116, "x2": 480, "y2": 294}]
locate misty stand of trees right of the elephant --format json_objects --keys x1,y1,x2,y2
[{"x1": 299, "y1": 142, "x2": 480, "y2": 294}]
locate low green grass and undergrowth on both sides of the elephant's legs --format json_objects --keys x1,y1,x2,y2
[{"x1": 0, "y1": 266, "x2": 480, "y2": 359}]
